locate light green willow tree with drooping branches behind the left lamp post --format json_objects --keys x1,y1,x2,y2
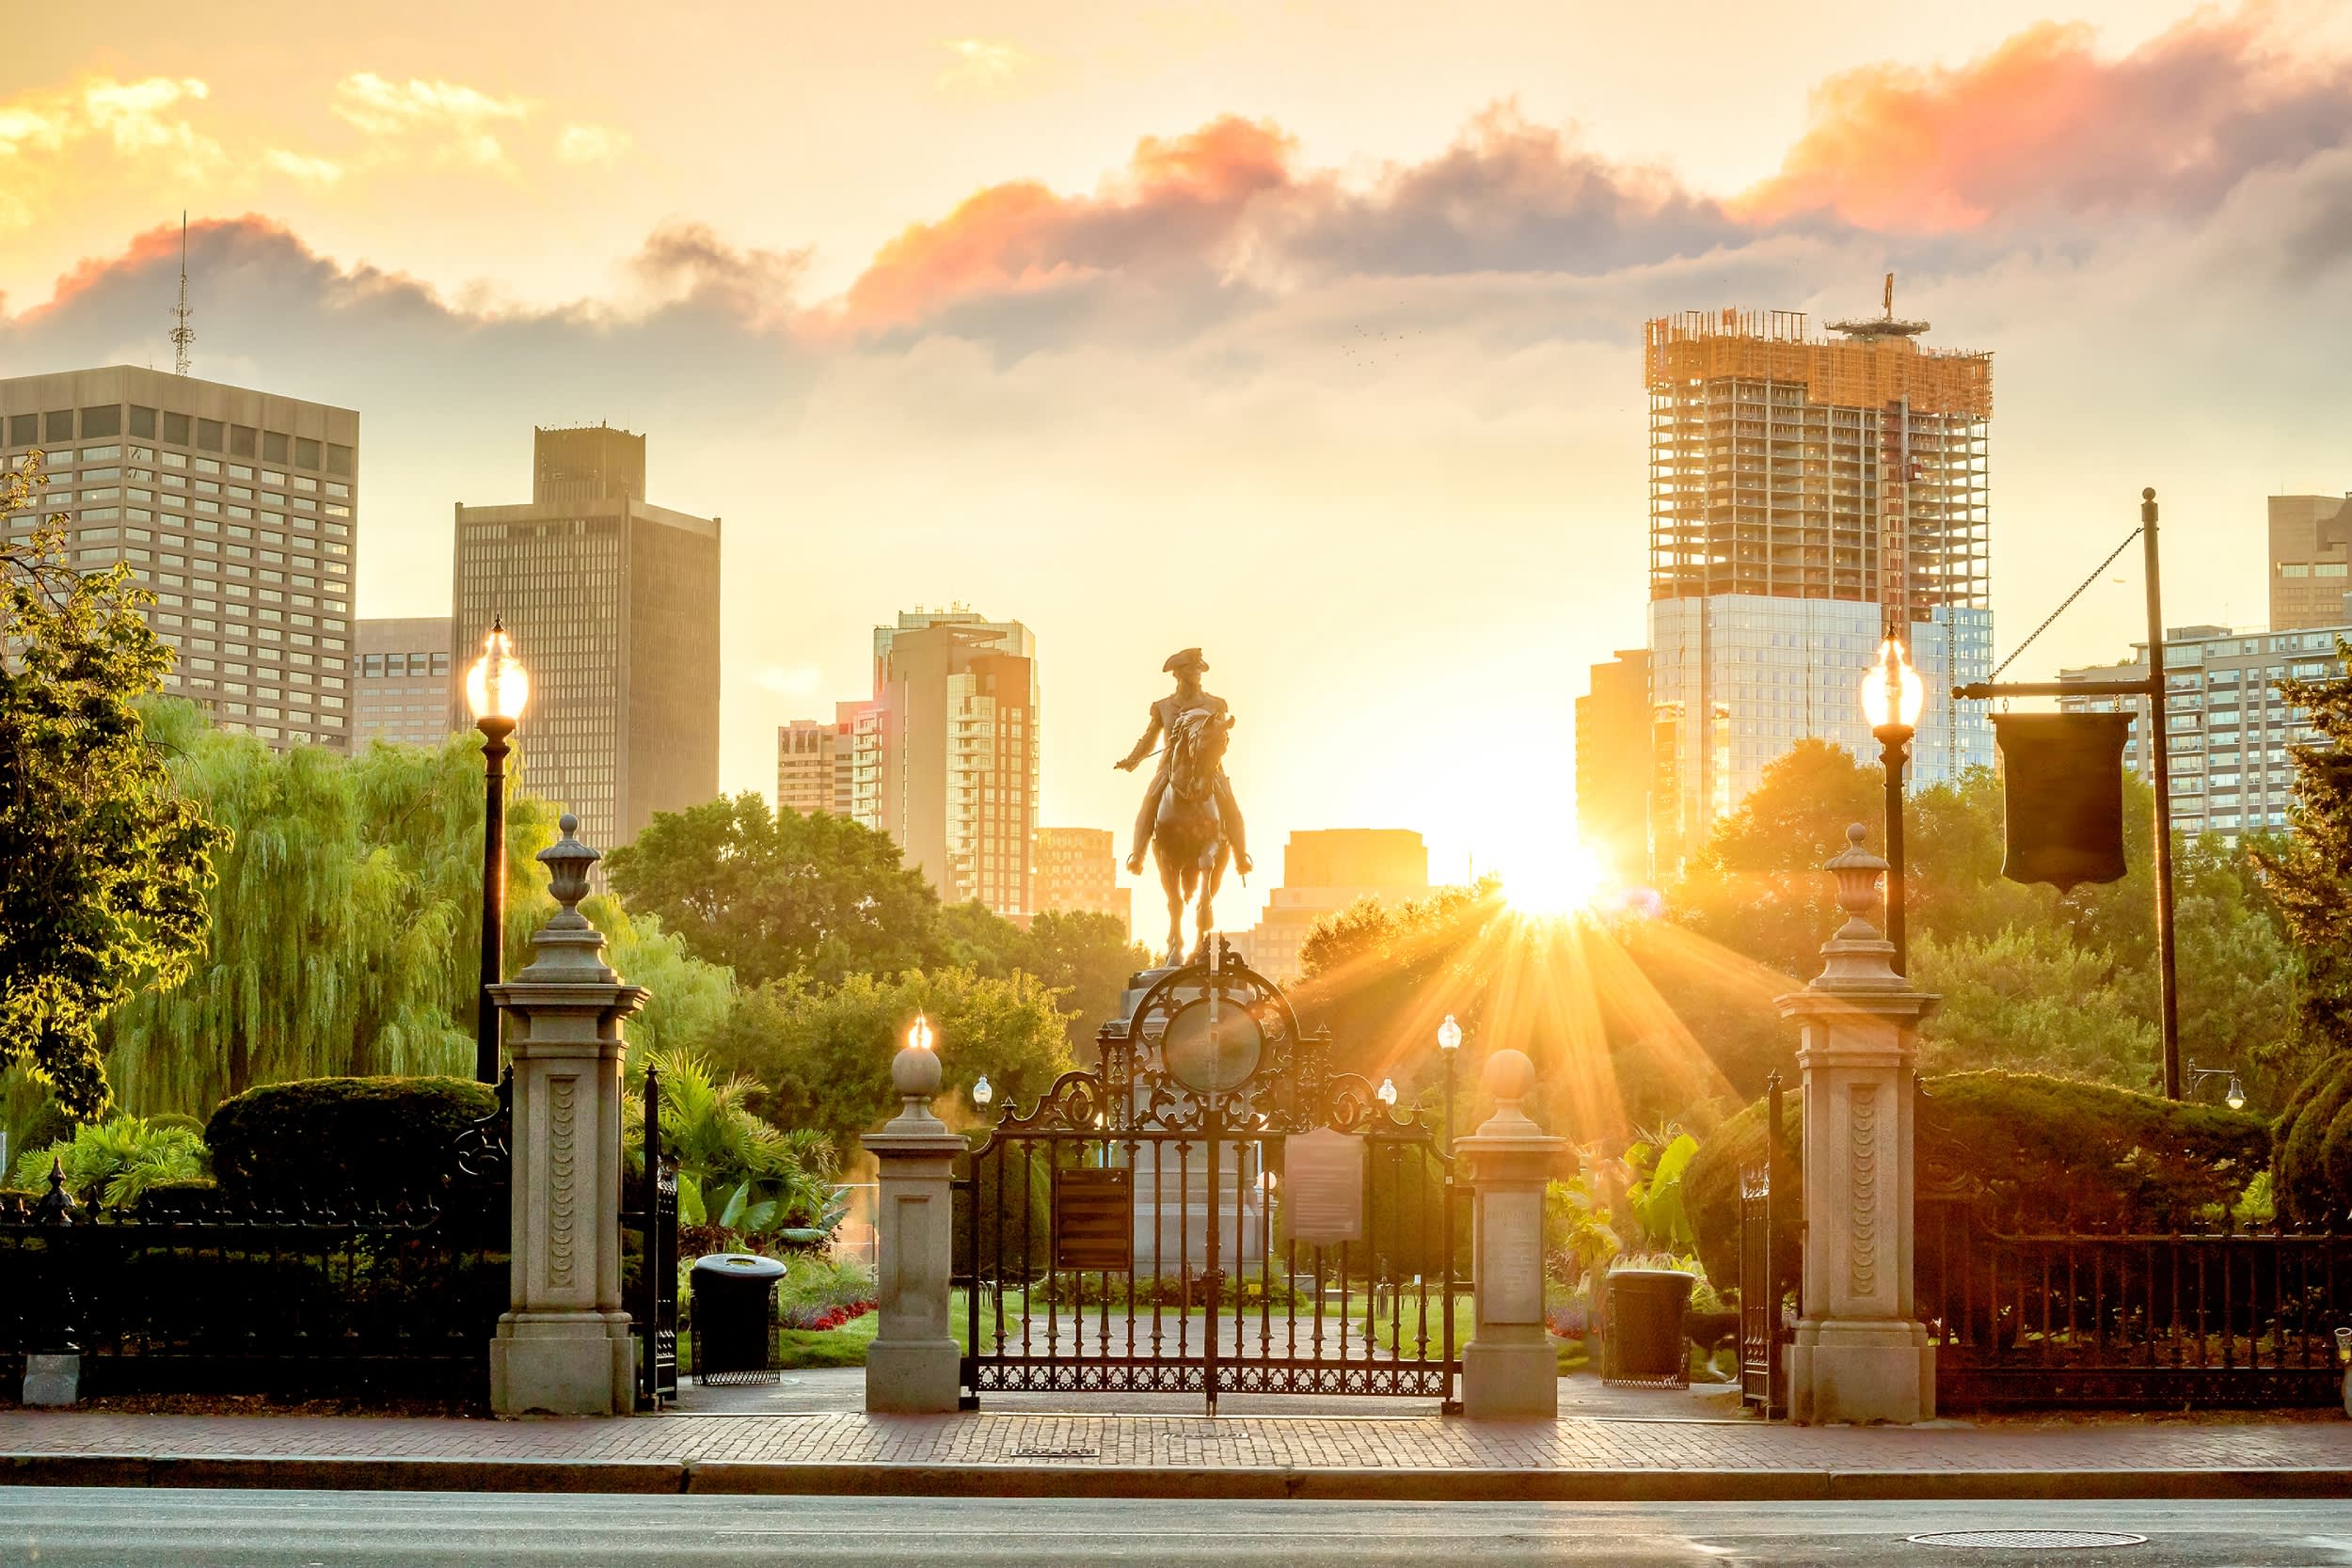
[{"x1": 106, "y1": 720, "x2": 569, "y2": 1117}]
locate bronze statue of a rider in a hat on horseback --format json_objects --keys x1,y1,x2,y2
[{"x1": 1113, "y1": 649, "x2": 1251, "y2": 964}]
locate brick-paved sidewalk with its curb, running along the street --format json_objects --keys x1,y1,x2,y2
[{"x1": 0, "y1": 1378, "x2": 2352, "y2": 1500}]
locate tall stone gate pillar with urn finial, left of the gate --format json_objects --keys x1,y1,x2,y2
[{"x1": 489, "y1": 816, "x2": 647, "y2": 1416}]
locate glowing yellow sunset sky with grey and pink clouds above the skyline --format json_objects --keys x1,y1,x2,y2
[{"x1": 0, "y1": 0, "x2": 2352, "y2": 927}]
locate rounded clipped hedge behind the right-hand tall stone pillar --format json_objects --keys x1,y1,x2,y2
[{"x1": 1682, "y1": 1072, "x2": 2270, "y2": 1284}]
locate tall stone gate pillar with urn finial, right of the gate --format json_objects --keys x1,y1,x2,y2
[{"x1": 1781, "y1": 825, "x2": 1936, "y2": 1425}]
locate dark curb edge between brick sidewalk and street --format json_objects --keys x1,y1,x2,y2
[{"x1": 0, "y1": 1453, "x2": 2352, "y2": 1502}]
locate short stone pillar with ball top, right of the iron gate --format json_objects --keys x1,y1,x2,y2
[{"x1": 1454, "y1": 1051, "x2": 1569, "y2": 1420}]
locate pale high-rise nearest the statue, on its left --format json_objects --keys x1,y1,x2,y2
[{"x1": 851, "y1": 609, "x2": 1038, "y2": 917}]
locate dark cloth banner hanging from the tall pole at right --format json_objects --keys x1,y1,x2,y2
[{"x1": 1993, "y1": 712, "x2": 2131, "y2": 894}]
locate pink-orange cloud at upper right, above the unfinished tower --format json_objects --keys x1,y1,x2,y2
[{"x1": 1736, "y1": 9, "x2": 2352, "y2": 232}]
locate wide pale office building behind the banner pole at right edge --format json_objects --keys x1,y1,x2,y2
[{"x1": 2058, "y1": 626, "x2": 2352, "y2": 839}]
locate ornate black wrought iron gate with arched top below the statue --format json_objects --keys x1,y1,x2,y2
[{"x1": 955, "y1": 955, "x2": 1470, "y2": 1413}]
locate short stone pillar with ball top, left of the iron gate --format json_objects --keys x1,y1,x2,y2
[{"x1": 861, "y1": 1044, "x2": 964, "y2": 1416}]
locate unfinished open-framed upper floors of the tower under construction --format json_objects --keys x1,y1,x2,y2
[{"x1": 1642, "y1": 309, "x2": 1993, "y2": 627}]
